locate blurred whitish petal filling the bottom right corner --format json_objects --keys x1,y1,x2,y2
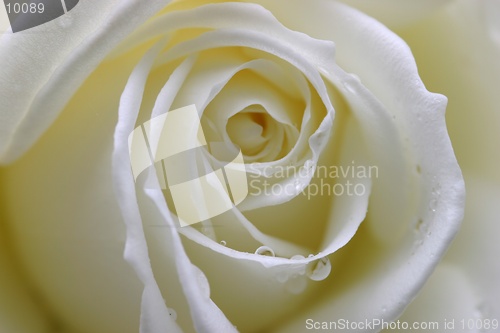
[{"x1": 390, "y1": 173, "x2": 500, "y2": 332}]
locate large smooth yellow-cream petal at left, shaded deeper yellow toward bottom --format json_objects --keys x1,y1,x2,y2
[{"x1": 0, "y1": 38, "x2": 156, "y2": 333}]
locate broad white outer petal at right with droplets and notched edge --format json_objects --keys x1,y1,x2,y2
[{"x1": 252, "y1": 0, "x2": 464, "y2": 320}]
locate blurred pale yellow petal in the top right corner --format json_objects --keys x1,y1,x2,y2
[{"x1": 398, "y1": 0, "x2": 500, "y2": 184}]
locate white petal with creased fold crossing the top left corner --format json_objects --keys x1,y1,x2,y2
[{"x1": 0, "y1": 0, "x2": 175, "y2": 163}]
